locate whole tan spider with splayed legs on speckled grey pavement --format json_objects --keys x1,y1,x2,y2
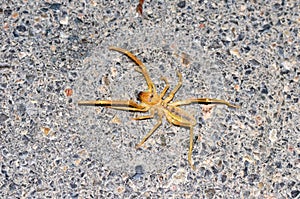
[{"x1": 78, "y1": 47, "x2": 239, "y2": 169}]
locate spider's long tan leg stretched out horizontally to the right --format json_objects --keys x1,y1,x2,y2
[{"x1": 169, "y1": 98, "x2": 240, "y2": 108}]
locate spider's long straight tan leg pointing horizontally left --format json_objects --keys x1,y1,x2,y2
[{"x1": 78, "y1": 100, "x2": 149, "y2": 112}]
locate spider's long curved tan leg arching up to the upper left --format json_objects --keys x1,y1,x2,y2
[{"x1": 109, "y1": 46, "x2": 156, "y2": 92}]
